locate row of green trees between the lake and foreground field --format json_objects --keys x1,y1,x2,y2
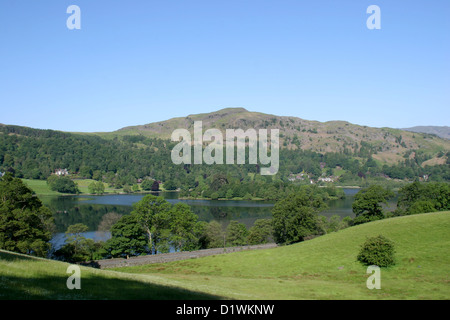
[{"x1": 0, "y1": 173, "x2": 450, "y2": 261}]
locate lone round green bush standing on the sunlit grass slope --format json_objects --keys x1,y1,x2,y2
[{"x1": 357, "y1": 235, "x2": 395, "y2": 267}]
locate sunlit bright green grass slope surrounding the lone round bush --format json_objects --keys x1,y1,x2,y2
[{"x1": 117, "y1": 211, "x2": 450, "y2": 299}]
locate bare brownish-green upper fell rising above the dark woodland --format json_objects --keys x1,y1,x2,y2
[{"x1": 113, "y1": 108, "x2": 450, "y2": 164}]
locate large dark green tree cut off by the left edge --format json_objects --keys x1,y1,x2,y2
[{"x1": 0, "y1": 173, "x2": 53, "y2": 257}]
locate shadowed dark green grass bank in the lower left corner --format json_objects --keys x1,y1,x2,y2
[{"x1": 0, "y1": 250, "x2": 217, "y2": 300}]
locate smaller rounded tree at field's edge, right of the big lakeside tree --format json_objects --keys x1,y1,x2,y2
[{"x1": 352, "y1": 185, "x2": 394, "y2": 224}]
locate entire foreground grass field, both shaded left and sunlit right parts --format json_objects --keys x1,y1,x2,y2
[{"x1": 0, "y1": 211, "x2": 450, "y2": 300}]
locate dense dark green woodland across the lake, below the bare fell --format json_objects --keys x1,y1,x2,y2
[{"x1": 0, "y1": 126, "x2": 450, "y2": 192}]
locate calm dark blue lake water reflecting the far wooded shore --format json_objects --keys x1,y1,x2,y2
[{"x1": 41, "y1": 189, "x2": 358, "y2": 249}]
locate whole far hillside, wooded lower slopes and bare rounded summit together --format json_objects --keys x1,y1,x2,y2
[{"x1": 0, "y1": 108, "x2": 450, "y2": 186}]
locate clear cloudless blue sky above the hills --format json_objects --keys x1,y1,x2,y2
[{"x1": 0, "y1": 0, "x2": 450, "y2": 132}]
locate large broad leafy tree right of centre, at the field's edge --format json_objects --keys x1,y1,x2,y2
[{"x1": 272, "y1": 186, "x2": 326, "y2": 244}]
